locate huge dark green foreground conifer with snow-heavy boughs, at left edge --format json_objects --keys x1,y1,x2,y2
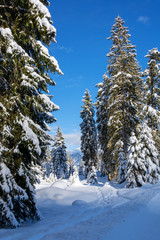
[{"x1": 0, "y1": 0, "x2": 61, "y2": 226}]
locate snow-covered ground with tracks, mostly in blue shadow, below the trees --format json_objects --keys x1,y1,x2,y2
[{"x1": 0, "y1": 179, "x2": 160, "y2": 240}]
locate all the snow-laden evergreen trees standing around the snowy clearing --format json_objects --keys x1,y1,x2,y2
[{"x1": 0, "y1": 0, "x2": 160, "y2": 228}]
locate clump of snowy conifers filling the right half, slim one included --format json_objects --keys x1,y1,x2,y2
[{"x1": 80, "y1": 16, "x2": 160, "y2": 187}]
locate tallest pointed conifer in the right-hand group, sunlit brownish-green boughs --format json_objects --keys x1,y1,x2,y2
[{"x1": 97, "y1": 16, "x2": 142, "y2": 182}]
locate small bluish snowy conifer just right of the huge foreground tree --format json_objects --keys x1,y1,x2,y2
[{"x1": 51, "y1": 127, "x2": 68, "y2": 179}]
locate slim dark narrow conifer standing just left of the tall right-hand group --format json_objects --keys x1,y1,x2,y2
[{"x1": 80, "y1": 90, "x2": 97, "y2": 177}]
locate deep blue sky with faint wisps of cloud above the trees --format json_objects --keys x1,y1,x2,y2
[{"x1": 49, "y1": 0, "x2": 160, "y2": 149}]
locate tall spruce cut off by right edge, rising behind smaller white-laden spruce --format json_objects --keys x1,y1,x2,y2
[{"x1": 143, "y1": 48, "x2": 160, "y2": 154}]
